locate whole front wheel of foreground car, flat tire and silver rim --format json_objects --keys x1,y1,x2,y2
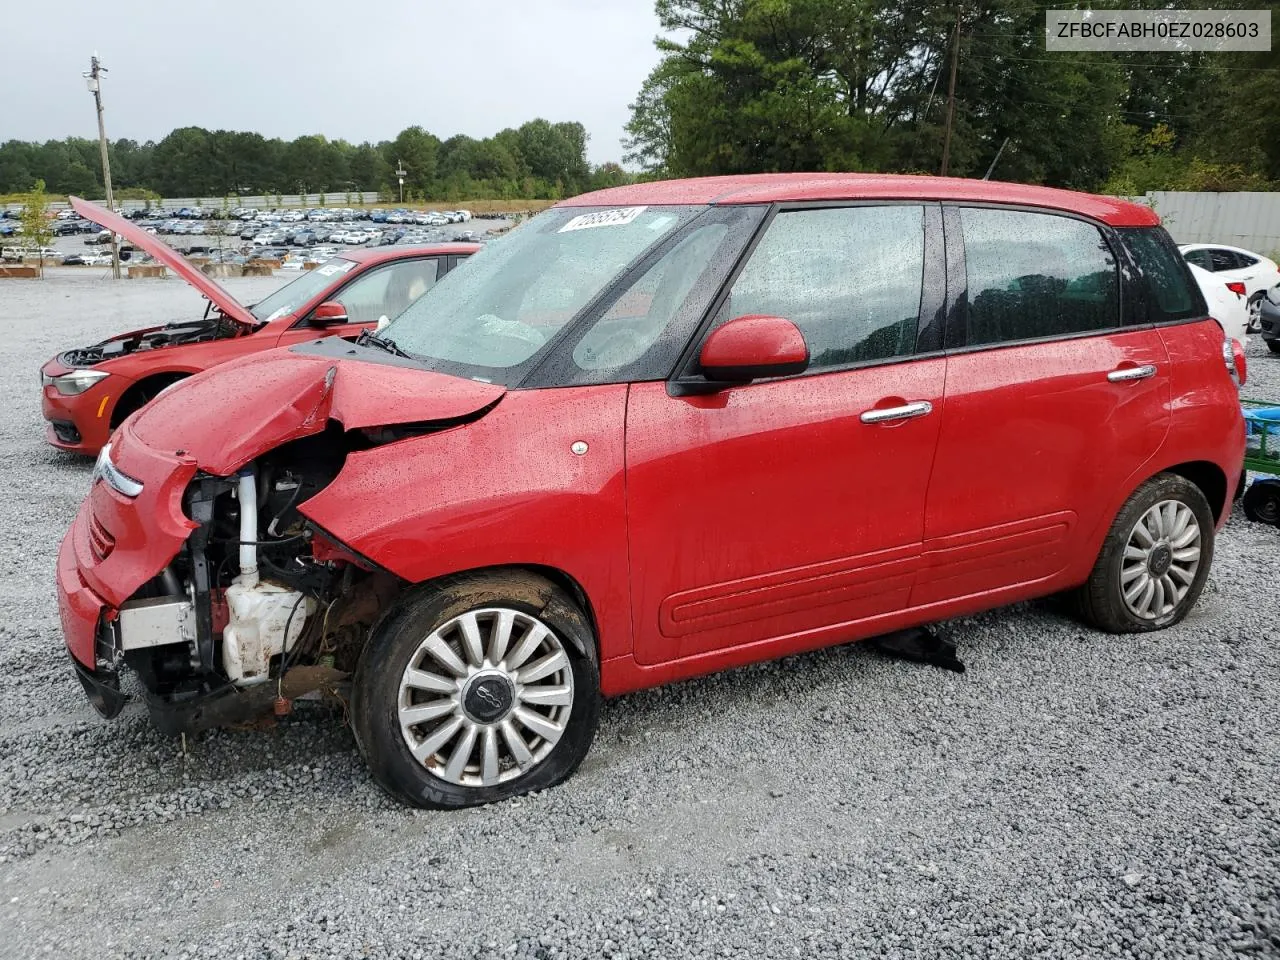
[{"x1": 351, "y1": 570, "x2": 600, "y2": 808}]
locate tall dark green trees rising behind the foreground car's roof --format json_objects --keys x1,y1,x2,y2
[{"x1": 627, "y1": 0, "x2": 1280, "y2": 195}]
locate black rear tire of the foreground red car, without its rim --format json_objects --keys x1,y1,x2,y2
[{"x1": 1075, "y1": 474, "x2": 1215, "y2": 634}]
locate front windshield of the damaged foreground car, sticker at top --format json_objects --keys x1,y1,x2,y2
[{"x1": 383, "y1": 206, "x2": 705, "y2": 387}]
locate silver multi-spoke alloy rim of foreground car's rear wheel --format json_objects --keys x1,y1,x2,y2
[{"x1": 1120, "y1": 500, "x2": 1201, "y2": 620}]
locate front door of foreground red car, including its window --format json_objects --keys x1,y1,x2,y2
[{"x1": 626, "y1": 204, "x2": 946, "y2": 664}]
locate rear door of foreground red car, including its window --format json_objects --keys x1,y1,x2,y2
[{"x1": 911, "y1": 207, "x2": 1170, "y2": 605}]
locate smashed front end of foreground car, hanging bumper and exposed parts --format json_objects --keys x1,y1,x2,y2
[{"x1": 56, "y1": 425, "x2": 376, "y2": 733}]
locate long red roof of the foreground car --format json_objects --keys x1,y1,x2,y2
[{"x1": 557, "y1": 173, "x2": 1160, "y2": 227}]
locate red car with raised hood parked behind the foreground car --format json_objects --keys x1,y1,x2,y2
[{"x1": 40, "y1": 197, "x2": 480, "y2": 454}]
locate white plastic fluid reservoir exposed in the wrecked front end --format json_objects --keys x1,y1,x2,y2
[{"x1": 223, "y1": 575, "x2": 315, "y2": 686}]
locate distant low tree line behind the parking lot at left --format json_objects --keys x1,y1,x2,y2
[{"x1": 0, "y1": 119, "x2": 627, "y2": 201}]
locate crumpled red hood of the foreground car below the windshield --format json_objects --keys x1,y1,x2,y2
[{"x1": 125, "y1": 348, "x2": 507, "y2": 476}]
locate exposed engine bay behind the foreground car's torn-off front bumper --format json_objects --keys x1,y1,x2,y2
[{"x1": 108, "y1": 422, "x2": 402, "y2": 732}]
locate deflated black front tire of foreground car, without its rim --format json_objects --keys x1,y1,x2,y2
[{"x1": 351, "y1": 568, "x2": 600, "y2": 809}]
